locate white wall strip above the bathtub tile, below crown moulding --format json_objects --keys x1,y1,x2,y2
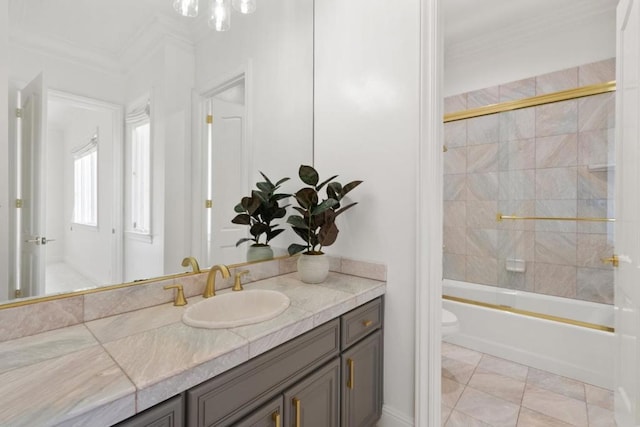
[{"x1": 443, "y1": 10, "x2": 616, "y2": 97}]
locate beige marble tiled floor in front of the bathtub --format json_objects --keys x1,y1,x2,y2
[{"x1": 442, "y1": 342, "x2": 616, "y2": 427}]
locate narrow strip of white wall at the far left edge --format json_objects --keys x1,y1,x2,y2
[{"x1": 0, "y1": 0, "x2": 10, "y2": 301}]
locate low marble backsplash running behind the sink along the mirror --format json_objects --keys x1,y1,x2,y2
[{"x1": 0, "y1": 257, "x2": 387, "y2": 342}]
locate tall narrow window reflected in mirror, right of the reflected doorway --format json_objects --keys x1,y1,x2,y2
[{"x1": 130, "y1": 120, "x2": 151, "y2": 234}]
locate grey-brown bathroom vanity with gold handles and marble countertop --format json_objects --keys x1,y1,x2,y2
[{"x1": 0, "y1": 264, "x2": 386, "y2": 427}]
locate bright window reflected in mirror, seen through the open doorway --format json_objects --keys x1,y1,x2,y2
[{"x1": 73, "y1": 140, "x2": 98, "y2": 227}]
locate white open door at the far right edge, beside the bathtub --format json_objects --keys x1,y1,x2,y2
[{"x1": 615, "y1": 0, "x2": 640, "y2": 427}]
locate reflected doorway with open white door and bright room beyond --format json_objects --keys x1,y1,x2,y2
[{"x1": 10, "y1": 81, "x2": 122, "y2": 298}]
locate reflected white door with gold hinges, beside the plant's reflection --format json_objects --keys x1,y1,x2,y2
[{"x1": 206, "y1": 75, "x2": 249, "y2": 265}]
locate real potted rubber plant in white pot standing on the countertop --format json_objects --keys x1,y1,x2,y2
[{"x1": 287, "y1": 165, "x2": 362, "y2": 283}]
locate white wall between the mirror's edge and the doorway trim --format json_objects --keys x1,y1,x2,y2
[{"x1": 314, "y1": 0, "x2": 420, "y2": 422}]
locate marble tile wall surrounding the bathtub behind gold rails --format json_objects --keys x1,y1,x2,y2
[{"x1": 443, "y1": 59, "x2": 615, "y2": 304}]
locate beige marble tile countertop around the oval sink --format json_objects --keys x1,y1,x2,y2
[{"x1": 0, "y1": 273, "x2": 386, "y2": 427}]
